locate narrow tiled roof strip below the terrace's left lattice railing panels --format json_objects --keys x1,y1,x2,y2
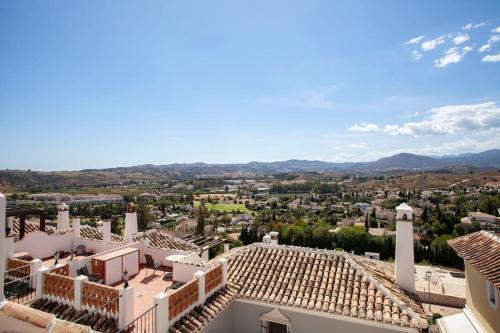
[{"x1": 30, "y1": 298, "x2": 118, "y2": 333}]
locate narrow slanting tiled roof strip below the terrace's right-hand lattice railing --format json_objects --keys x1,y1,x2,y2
[{"x1": 169, "y1": 287, "x2": 236, "y2": 333}]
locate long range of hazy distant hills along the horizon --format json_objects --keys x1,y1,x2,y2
[{"x1": 0, "y1": 149, "x2": 500, "y2": 191}]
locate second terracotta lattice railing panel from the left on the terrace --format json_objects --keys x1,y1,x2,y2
[{"x1": 82, "y1": 282, "x2": 119, "y2": 315}]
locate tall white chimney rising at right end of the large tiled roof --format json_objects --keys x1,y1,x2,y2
[{"x1": 395, "y1": 203, "x2": 415, "y2": 294}]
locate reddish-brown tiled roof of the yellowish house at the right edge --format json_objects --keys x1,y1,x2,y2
[{"x1": 448, "y1": 230, "x2": 500, "y2": 288}]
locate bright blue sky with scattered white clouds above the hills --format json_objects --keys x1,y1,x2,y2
[{"x1": 0, "y1": 0, "x2": 500, "y2": 170}]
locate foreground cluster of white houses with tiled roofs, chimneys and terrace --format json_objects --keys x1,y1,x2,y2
[{"x1": 0, "y1": 194, "x2": 500, "y2": 333}]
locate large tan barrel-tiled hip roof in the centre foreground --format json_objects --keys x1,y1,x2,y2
[{"x1": 229, "y1": 244, "x2": 427, "y2": 328}]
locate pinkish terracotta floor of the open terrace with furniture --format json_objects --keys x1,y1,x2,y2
[{"x1": 113, "y1": 264, "x2": 173, "y2": 318}]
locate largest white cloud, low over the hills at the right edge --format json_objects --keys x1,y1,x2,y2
[{"x1": 383, "y1": 102, "x2": 500, "y2": 136}]
